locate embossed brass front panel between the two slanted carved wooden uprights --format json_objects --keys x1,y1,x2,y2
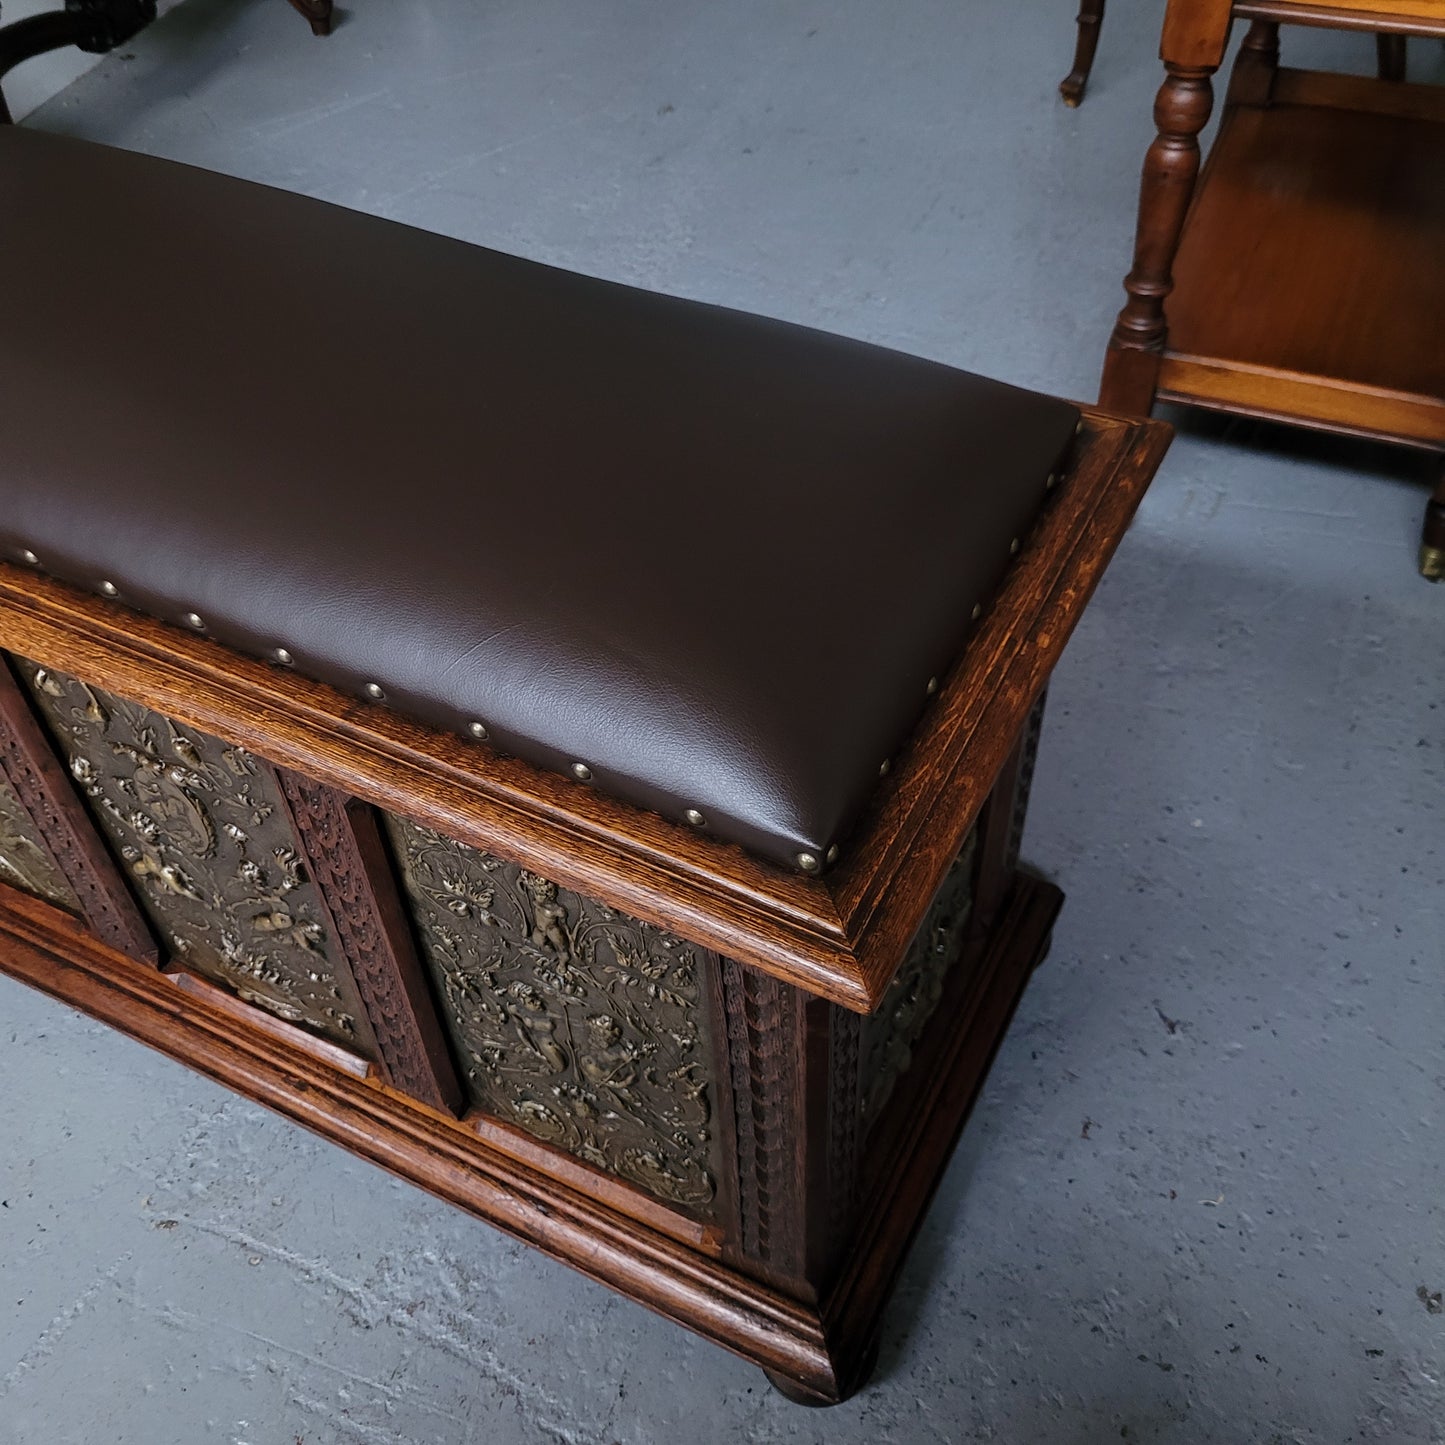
[{"x1": 16, "y1": 659, "x2": 376, "y2": 1058}]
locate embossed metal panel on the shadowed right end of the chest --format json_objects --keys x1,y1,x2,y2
[{"x1": 858, "y1": 828, "x2": 978, "y2": 1130}]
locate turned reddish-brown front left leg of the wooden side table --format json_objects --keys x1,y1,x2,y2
[{"x1": 1100, "y1": 61, "x2": 1218, "y2": 416}]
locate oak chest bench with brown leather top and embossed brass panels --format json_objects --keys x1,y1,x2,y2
[{"x1": 0, "y1": 129, "x2": 1168, "y2": 1403}]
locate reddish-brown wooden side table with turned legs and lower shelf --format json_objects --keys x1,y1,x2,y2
[{"x1": 1101, "y1": 0, "x2": 1445, "y2": 581}]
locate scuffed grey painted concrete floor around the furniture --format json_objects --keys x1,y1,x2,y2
[{"x1": 0, "y1": 0, "x2": 1445, "y2": 1445}]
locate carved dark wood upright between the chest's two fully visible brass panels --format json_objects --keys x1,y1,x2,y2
[{"x1": 276, "y1": 767, "x2": 462, "y2": 1114}]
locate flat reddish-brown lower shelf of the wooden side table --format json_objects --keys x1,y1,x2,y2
[{"x1": 1159, "y1": 71, "x2": 1445, "y2": 449}]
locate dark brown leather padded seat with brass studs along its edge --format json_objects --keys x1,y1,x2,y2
[{"x1": 0, "y1": 127, "x2": 1078, "y2": 867}]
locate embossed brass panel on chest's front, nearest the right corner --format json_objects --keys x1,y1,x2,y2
[{"x1": 387, "y1": 816, "x2": 717, "y2": 1211}]
